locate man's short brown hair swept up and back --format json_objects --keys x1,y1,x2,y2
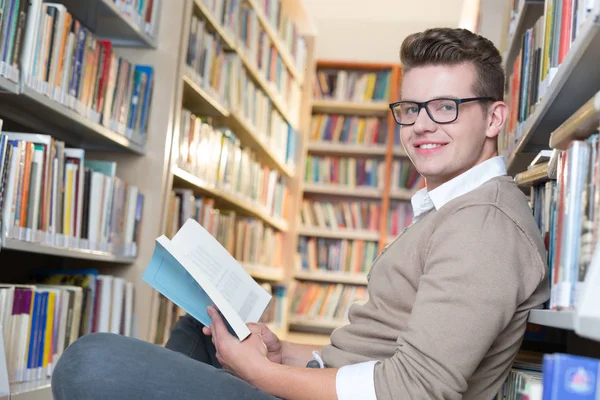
[{"x1": 400, "y1": 28, "x2": 504, "y2": 100}]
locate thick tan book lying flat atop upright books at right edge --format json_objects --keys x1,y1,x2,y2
[{"x1": 550, "y1": 91, "x2": 600, "y2": 150}]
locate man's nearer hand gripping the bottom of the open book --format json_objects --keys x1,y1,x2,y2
[{"x1": 203, "y1": 307, "x2": 279, "y2": 385}]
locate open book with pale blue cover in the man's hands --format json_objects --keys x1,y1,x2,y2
[{"x1": 142, "y1": 219, "x2": 271, "y2": 340}]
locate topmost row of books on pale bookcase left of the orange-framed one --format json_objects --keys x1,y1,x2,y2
[{"x1": 250, "y1": 0, "x2": 306, "y2": 71}]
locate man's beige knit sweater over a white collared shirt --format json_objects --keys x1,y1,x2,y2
[{"x1": 322, "y1": 176, "x2": 549, "y2": 400}]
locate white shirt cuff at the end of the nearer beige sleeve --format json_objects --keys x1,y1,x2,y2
[{"x1": 335, "y1": 361, "x2": 378, "y2": 400}]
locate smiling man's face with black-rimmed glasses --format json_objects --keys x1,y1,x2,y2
[{"x1": 400, "y1": 64, "x2": 488, "y2": 190}]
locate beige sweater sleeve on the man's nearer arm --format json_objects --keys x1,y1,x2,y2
[{"x1": 374, "y1": 205, "x2": 544, "y2": 400}]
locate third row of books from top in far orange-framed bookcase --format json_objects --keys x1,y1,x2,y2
[{"x1": 304, "y1": 155, "x2": 385, "y2": 188}]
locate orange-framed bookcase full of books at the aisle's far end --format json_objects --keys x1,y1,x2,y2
[{"x1": 289, "y1": 60, "x2": 419, "y2": 334}]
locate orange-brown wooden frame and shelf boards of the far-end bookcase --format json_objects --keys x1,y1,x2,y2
[{"x1": 289, "y1": 60, "x2": 416, "y2": 338}]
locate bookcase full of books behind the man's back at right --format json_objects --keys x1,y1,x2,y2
[{"x1": 498, "y1": 0, "x2": 600, "y2": 398}]
